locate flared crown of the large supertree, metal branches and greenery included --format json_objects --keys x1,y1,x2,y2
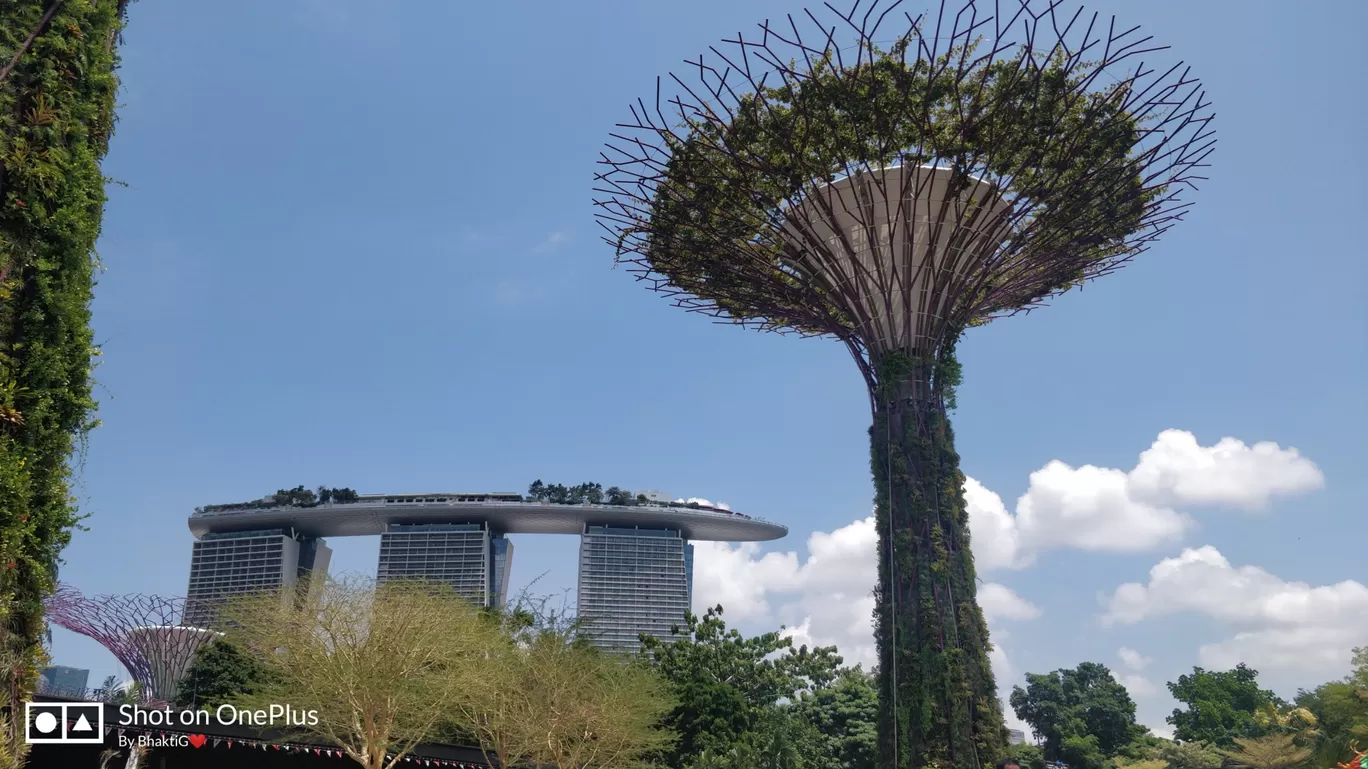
[{"x1": 594, "y1": 0, "x2": 1215, "y2": 389}]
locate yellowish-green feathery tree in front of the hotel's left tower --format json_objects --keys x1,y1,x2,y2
[{"x1": 220, "y1": 579, "x2": 499, "y2": 769}]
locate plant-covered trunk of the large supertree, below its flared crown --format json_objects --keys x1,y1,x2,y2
[{"x1": 870, "y1": 346, "x2": 1005, "y2": 769}]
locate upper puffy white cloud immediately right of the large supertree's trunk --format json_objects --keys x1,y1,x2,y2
[{"x1": 964, "y1": 430, "x2": 1324, "y2": 571}]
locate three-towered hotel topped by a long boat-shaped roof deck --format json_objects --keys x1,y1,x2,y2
[{"x1": 183, "y1": 493, "x2": 788, "y2": 651}]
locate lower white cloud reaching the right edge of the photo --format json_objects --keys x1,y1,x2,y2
[{"x1": 1103, "y1": 545, "x2": 1368, "y2": 673}]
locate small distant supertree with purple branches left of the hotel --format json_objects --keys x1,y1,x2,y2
[{"x1": 44, "y1": 584, "x2": 220, "y2": 703}]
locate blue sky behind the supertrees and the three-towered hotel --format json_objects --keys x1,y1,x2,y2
[{"x1": 55, "y1": 0, "x2": 1368, "y2": 725}]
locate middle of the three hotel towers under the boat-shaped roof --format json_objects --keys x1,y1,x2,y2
[{"x1": 376, "y1": 523, "x2": 513, "y2": 606}]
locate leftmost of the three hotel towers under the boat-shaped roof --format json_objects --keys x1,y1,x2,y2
[{"x1": 185, "y1": 530, "x2": 332, "y2": 627}]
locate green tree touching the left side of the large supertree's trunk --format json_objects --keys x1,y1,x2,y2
[{"x1": 795, "y1": 666, "x2": 875, "y2": 769}]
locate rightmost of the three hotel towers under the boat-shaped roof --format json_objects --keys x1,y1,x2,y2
[{"x1": 579, "y1": 525, "x2": 694, "y2": 653}]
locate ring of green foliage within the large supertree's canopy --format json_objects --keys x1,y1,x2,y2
[{"x1": 634, "y1": 37, "x2": 1164, "y2": 337}]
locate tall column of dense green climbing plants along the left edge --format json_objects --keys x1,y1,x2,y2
[{"x1": 0, "y1": 0, "x2": 127, "y2": 766}]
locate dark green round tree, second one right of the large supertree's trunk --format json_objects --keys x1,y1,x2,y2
[{"x1": 1167, "y1": 662, "x2": 1282, "y2": 748}]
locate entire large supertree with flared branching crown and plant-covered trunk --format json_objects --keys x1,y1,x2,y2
[{"x1": 595, "y1": 0, "x2": 1215, "y2": 769}]
